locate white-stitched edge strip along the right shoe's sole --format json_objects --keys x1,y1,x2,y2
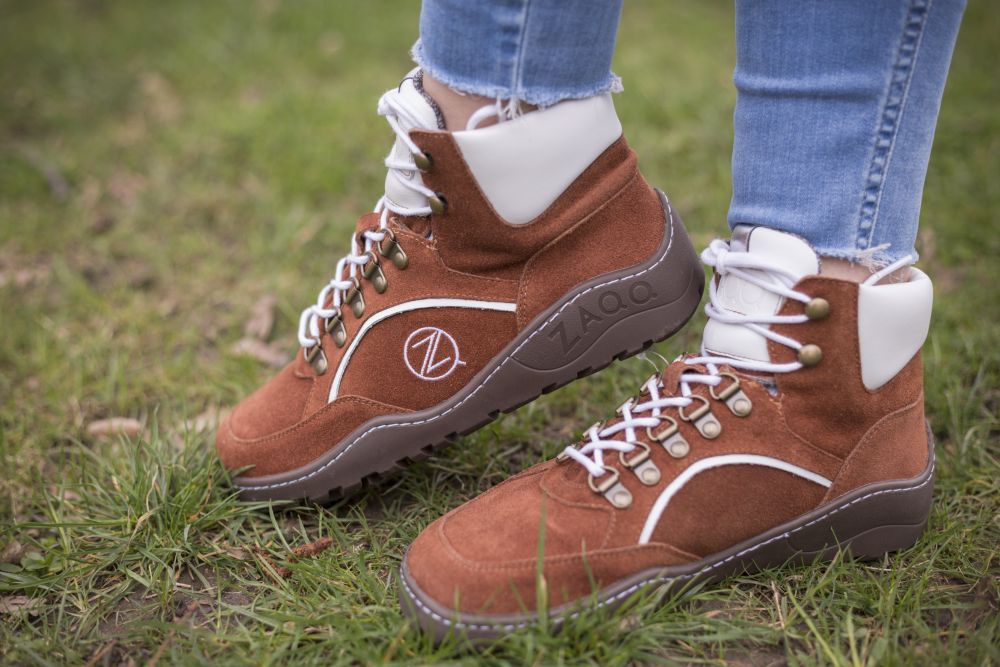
[{"x1": 399, "y1": 460, "x2": 936, "y2": 632}]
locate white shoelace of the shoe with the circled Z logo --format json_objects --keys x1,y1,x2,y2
[{"x1": 299, "y1": 88, "x2": 434, "y2": 350}]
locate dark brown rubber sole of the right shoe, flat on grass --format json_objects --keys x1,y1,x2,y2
[{"x1": 399, "y1": 427, "x2": 934, "y2": 642}]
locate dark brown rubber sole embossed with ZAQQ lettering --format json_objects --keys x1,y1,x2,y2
[{"x1": 234, "y1": 191, "x2": 705, "y2": 502}]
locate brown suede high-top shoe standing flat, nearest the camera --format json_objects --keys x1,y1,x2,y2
[{"x1": 400, "y1": 227, "x2": 934, "y2": 638}]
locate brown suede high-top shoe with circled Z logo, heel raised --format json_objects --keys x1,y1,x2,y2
[{"x1": 217, "y1": 72, "x2": 704, "y2": 501}]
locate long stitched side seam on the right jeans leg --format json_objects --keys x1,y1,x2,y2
[{"x1": 855, "y1": 0, "x2": 933, "y2": 250}]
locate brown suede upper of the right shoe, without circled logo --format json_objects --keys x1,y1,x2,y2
[{"x1": 406, "y1": 277, "x2": 927, "y2": 614}]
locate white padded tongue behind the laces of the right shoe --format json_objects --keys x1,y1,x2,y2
[{"x1": 703, "y1": 225, "x2": 819, "y2": 362}]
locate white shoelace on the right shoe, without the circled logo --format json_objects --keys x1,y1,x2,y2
[{"x1": 563, "y1": 239, "x2": 914, "y2": 478}]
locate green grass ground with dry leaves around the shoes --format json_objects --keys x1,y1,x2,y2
[{"x1": 0, "y1": 0, "x2": 1000, "y2": 665}]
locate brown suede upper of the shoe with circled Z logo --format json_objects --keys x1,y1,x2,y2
[{"x1": 216, "y1": 130, "x2": 664, "y2": 477}]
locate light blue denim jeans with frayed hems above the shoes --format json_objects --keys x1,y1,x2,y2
[{"x1": 413, "y1": 0, "x2": 965, "y2": 262}]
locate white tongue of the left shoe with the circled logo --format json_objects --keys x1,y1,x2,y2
[{"x1": 385, "y1": 68, "x2": 444, "y2": 214}]
